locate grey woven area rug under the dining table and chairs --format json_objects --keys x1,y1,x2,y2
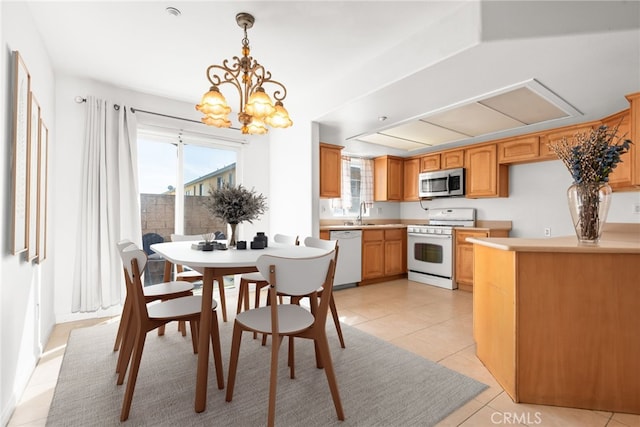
[{"x1": 47, "y1": 321, "x2": 487, "y2": 427}]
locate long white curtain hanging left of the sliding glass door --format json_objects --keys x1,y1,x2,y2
[{"x1": 71, "y1": 96, "x2": 142, "y2": 312}]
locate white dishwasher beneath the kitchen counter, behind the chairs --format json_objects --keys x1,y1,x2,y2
[{"x1": 329, "y1": 230, "x2": 362, "y2": 288}]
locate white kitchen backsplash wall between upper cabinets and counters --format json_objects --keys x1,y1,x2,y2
[{"x1": 319, "y1": 160, "x2": 640, "y2": 238}]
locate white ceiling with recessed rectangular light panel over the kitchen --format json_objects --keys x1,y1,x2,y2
[{"x1": 26, "y1": 0, "x2": 640, "y2": 156}]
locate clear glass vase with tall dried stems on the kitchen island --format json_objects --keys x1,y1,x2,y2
[{"x1": 549, "y1": 126, "x2": 632, "y2": 244}]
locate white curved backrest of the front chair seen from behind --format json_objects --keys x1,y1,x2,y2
[{"x1": 257, "y1": 251, "x2": 334, "y2": 296}]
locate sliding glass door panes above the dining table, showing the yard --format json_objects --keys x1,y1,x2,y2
[{"x1": 138, "y1": 128, "x2": 238, "y2": 240}]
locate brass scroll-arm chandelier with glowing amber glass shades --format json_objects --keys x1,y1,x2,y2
[{"x1": 196, "y1": 13, "x2": 293, "y2": 135}]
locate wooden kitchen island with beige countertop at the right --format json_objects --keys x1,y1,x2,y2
[{"x1": 468, "y1": 224, "x2": 640, "y2": 414}]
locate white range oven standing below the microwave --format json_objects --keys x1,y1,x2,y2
[{"x1": 407, "y1": 208, "x2": 476, "y2": 289}]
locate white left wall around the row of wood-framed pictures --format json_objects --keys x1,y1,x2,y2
[{"x1": 0, "y1": 2, "x2": 56, "y2": 425}]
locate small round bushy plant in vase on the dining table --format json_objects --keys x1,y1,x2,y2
[{"x1": 203, "y1": 183, "x2": 267, "y2": 247}]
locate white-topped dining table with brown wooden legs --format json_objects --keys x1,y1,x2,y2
[{"x1": 151, "y1": 242, "x2": 327, "y2": 412}]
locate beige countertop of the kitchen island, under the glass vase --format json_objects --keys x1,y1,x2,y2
[{"x1": 466, "y1": 224, "x2": 640, "y2": 254}]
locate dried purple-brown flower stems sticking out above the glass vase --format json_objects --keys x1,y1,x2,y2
[{"x1": 549, "y1": 125, "x2": 632, "y2": 184}]
